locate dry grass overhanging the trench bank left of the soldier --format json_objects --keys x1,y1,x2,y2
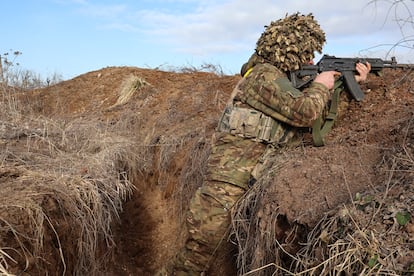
[{"x1": 0, "y1": 85, "x2": 140, "y2": 275}]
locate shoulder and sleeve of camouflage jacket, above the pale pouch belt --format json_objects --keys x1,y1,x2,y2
[{"x1": 235, "y1": 63, "x2": 330, "y2": 127}]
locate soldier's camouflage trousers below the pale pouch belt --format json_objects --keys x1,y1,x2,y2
[{"x1": 173, "y1": 133, "x2": 266, "y2": 275}]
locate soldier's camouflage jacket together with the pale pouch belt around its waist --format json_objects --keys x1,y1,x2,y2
[{"x1": 218, "y1": 63, "x2": 330, "y2": 144}]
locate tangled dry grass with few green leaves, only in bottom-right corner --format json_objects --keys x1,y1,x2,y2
[{"x1": 294, "y1": 118, "x2": 414, "y2": 275}]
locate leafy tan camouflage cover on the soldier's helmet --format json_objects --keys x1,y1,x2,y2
[{"x1": 256, "y1": 13, "x2": 325, "y2": 71}]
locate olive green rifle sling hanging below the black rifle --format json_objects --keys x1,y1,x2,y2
[{"x1": 312, "y1": 81, "x2": 343, "y2": 147}]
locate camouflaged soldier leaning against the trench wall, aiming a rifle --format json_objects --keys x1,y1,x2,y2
[{"x1": 162, "y1": 13, "x2": 370, "y2": 275}]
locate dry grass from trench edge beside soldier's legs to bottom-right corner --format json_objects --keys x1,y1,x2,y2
[{"x1": 232, "y1": 115, "x2": 414, "y2": 275}]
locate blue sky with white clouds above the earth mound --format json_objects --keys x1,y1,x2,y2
[{"x1": 0, "y1": 0, "x2": 414, "y2": 79}]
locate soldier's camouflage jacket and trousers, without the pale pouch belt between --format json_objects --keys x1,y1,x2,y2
[{"x1": 174, "y1": 64, "x2": 329, "y2": 275}]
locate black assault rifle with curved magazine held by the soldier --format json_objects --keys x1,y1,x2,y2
[{"x1": 289, "y1": 55, "x2": 414, "y2": 101}]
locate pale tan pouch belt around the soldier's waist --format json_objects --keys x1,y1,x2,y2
[{"x1": 217, "y1": 106, "x2": 292, "y2": 144}]
